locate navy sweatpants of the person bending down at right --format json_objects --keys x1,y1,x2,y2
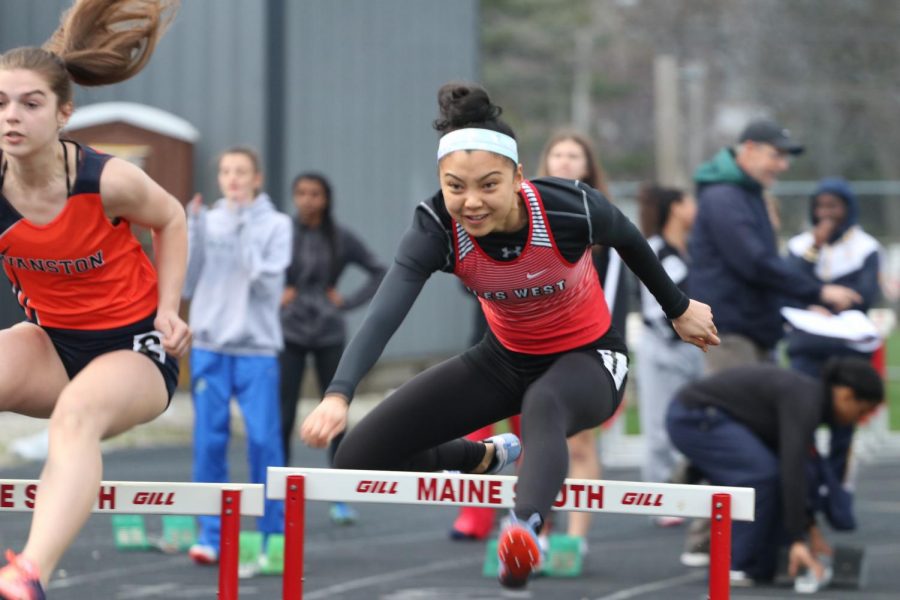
[{"x1": 666, "y1": 398, "x2": 786, "y2": 581}]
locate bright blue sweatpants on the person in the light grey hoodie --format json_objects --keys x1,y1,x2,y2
[{"x1": 191, "y1": 350, "x2": 284, "y2": 548}]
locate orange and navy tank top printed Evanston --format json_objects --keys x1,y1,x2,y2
[{"x1": 0, "y1": 146, "x2": 158, "y2": 330}]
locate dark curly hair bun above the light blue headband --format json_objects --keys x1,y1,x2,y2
[{"x1": 433, "y1": 81, "x2": 516, "y2": 139}]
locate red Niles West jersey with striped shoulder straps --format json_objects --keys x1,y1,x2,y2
[{"x1": 453, "y1": 181, "x2": 610, "y2": 354}]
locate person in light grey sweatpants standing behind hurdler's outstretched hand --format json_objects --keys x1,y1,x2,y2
[{"x1": 636, "y1": 184, "x2": 703, "y2": 496}]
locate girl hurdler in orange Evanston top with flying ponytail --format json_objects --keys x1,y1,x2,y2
[{"x1": 0, "y1": 0, "x2": 191, "y2": 600}]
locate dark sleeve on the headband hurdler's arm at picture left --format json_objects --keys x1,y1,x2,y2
[{"x1": 325, "y1": 210, "x2": 448, "y2": 399}]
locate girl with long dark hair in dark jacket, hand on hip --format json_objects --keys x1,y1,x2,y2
[{"x1": 281, "y1": 173, "x2": 385, "y2": 523}]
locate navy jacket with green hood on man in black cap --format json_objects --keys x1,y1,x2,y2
[{"x1": 688, "y1": 148, "x2": 822, "y2": 349}]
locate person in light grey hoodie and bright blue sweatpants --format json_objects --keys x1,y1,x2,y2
[{"x1": 184, "y1": 147, "x2": 292, "y2": 564}]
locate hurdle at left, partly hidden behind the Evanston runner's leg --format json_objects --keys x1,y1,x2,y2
[{"x1": 0, "y1": 479, "x2": 265, "y2": 600}]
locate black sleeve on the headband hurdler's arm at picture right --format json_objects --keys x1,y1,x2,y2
[{"x1": 579, "y1": 184, "x2": 690, "y2": 319}]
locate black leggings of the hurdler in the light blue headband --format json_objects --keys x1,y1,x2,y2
[{"x1": 334, "y1": 333, "x2": 627, "y2": 519}]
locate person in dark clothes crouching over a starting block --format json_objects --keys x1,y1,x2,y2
[{"x1": 666, "y1": 357, "x2": 884, "y2": 584}]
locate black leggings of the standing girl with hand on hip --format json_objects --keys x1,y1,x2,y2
[{"x1": 279, "y1": 342, "x2": 344, "y2": 465}]
